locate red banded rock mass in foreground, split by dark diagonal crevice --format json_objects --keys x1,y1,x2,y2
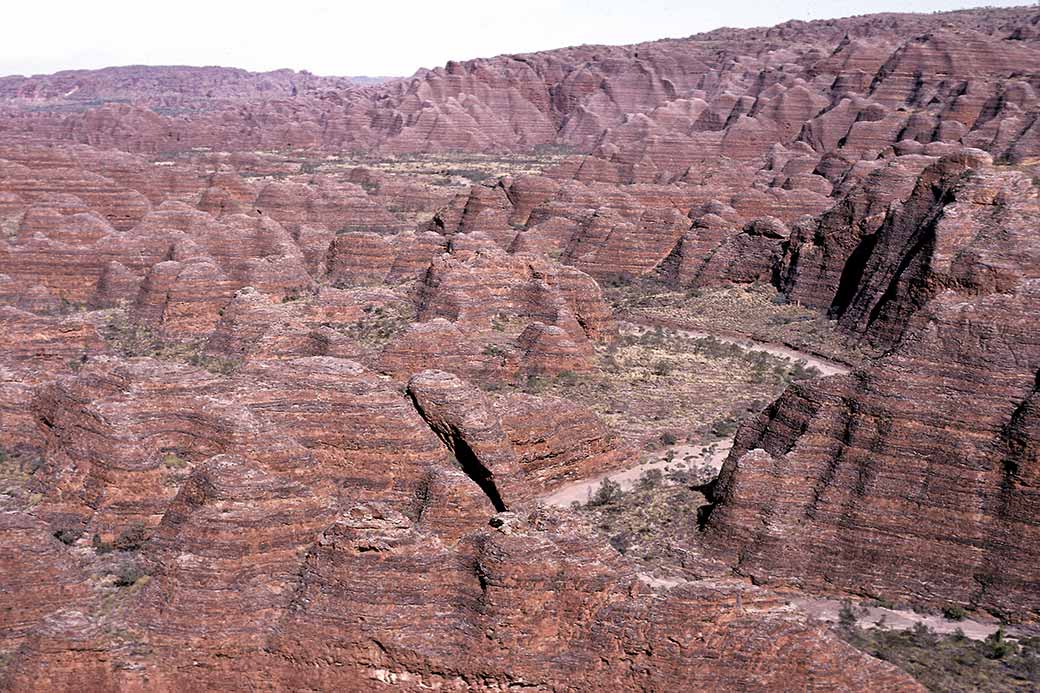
[{"x1": 4, "y1": 357, "x2": 923, "y2": 690}]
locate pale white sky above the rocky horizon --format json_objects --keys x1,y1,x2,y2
[{"x1": 0, "y1": 0, "x2": 1023, "y2": 75}]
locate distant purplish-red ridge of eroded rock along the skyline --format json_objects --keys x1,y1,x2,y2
[{"x1": 0, "y1": 7, "x2": 1040, "y2": 164}]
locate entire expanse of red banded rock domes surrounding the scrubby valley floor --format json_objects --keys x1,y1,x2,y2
[{"x1": 0, "y1": 8, "x2": 1040, "y2": 691}]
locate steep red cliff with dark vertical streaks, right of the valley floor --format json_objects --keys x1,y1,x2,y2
[{"x1": 707, "y1": 160, "x2": 1040, "y2": 620}]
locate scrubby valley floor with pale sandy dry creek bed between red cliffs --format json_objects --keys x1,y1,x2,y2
[{"x1": 553, "y1": 286, "x2": 1040, "y2": 692}]
